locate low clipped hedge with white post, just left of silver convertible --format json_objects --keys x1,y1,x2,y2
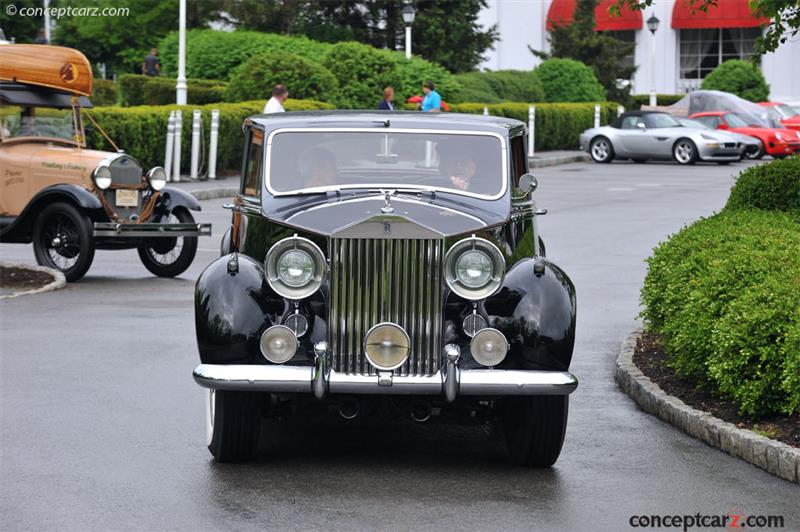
[{"x1": 451, "y1": 102, "x2": 618, "y2": 150}]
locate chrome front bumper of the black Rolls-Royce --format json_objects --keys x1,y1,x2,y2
[{"x1": 193, "y1": 359, "x2": 578, "y2": 401}]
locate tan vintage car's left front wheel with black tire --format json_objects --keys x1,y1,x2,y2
[{"x1": 33, "y1": 202, "x2": 94, "y2": 282}]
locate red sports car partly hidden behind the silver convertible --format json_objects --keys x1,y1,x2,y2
[{"x1": 689, "y1": 111, "x2": 800, "y2": 159}]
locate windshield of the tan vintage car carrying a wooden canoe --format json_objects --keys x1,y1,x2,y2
[{"x1": 0, "y1": 105, "x2": 75, "y2": 142}]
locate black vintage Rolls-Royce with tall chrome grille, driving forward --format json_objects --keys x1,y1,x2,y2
[{"x1": 194, "y1": 112, "x2": 578, "y2": 466}]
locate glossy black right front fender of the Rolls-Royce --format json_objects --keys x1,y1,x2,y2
[{"x1": 485, "y1": 257, "x2": 577, "y2": 371}]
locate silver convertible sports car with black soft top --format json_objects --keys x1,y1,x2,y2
[{"x1": 580, "y1": 111, "x2": 743, "y2": 164}]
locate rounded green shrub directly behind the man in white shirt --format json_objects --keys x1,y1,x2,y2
[{"x1": 225, "y1": 53, "x2": 339, "y2": 102}]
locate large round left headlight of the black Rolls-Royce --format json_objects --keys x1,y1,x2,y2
[{"x1": 265, "y1": 236, "x2": 325, "y2": 299}]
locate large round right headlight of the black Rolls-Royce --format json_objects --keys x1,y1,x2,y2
[{"x1": 444, "y1": 236, "x2": 506, "y2": 301}]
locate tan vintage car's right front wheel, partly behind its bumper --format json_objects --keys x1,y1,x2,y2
[{"x1": 138, "y1": 209, "x2": 197, "y2": 277}]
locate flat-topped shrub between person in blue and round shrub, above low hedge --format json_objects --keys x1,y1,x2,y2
[{"x1": 450, "y1": 70, "x2": 544, "y2": 103}]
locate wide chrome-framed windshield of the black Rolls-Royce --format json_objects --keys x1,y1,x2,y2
[{"x1": 266, "y1": 129, "x2": 506, "y2": 197}]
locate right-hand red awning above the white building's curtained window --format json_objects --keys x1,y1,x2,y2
[{"x1": 672, "y1": 0, "x2": 769, "y2": 29}]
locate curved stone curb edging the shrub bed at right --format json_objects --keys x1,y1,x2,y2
[{"x1": 614, "y1": 328, "x2": 800, "y2": 484}]
